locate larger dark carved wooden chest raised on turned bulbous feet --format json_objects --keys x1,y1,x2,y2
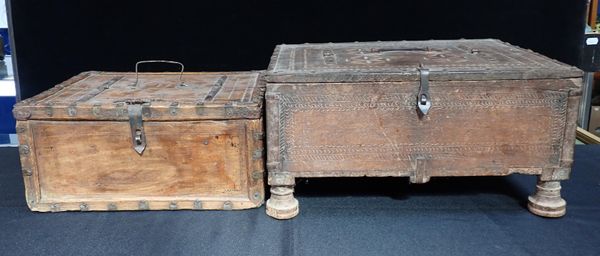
[{"x1": 265, "y1": 39, "x2": 582, "y2": 219}]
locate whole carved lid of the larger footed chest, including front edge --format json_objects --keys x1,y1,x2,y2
[{"x1": 266, "y1": 39, "x2": 582, "y2": 83}]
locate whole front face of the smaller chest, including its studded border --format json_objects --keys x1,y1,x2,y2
[{"x1": 18, "y1": 120, "x2": 263, "y2": 211}]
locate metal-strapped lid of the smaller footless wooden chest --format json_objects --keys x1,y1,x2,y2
[{"x1": 13, "y1": 71, "x2": 264, "y2": 121}]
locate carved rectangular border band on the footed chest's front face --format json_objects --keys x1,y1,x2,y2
[{"x1": 279, "y1": 91, "x2": 568, "y2": 164}]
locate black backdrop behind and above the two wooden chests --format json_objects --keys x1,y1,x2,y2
[{"x1": 10, "y1": 0, "x2": 586, "y2": 98}]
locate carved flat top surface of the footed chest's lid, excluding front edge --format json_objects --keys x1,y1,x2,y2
[{"x1": 273, "y1": 40, "x2": 572, "y2": 72}]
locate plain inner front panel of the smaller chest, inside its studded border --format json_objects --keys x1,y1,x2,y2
[{"x1": 32, "y1": 121, "x2": 247, "y2": 201}]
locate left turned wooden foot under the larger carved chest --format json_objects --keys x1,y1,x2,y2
[{"x1": 266, "y1": 186, "x2": 299, "y2": 220}]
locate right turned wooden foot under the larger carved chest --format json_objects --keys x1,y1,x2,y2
[{"x1": 527, "y1": 181, "x2": 567, "y2": 218}]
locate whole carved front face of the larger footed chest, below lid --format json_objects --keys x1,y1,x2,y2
[{"x1": 267, "y1": 80, "x2": 569, "y2": 176}]
